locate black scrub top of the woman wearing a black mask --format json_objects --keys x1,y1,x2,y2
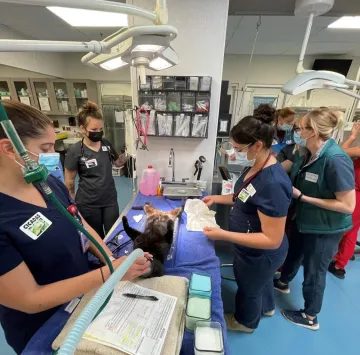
[{"x1": 65, "y1": 139, "x2": 119, "y2": 207}]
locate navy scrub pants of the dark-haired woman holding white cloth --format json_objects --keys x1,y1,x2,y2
[{"x1": 234, "y1": 243, "x2": 288, "y2": 329}]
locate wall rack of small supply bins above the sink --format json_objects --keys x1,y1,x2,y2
[{"x1": 138, "y1": 75, "x2": 211, "y2": 139}]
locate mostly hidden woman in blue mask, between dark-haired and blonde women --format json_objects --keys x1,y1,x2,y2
[{"x1": 271, "y1": 107, "x2": 295, "y2": 155}]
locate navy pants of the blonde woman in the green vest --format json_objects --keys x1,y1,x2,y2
[{"x1": 280, "y1": 227, "x2": 344, "y2": 317}]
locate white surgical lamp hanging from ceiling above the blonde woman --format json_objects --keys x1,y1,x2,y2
[{"x1": 281, "y1": 0, "x2": 360, "y2": 99}]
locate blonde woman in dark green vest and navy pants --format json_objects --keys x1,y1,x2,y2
[{"x1": 274, "y1": 108, "x2": 355, "y2": 330}]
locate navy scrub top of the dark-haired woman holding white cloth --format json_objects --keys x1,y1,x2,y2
[{"x1": 229, "y1": 163, "x2": 292, "y2": 256}]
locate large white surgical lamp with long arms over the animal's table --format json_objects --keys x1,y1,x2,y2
[{"x1": 0, "y1": 0, "x2": 179, "y2": 83}]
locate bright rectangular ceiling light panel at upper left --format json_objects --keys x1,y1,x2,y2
[{"x1": 47, "y1": 6, "x2": 128, "y2": 27}]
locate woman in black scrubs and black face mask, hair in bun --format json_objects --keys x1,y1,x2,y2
[{"x1": 65, "y1": 102, "x2": 125, "y2": 239}]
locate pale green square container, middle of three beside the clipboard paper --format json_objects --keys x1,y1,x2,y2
[{"x1": 185, "y1": 296, "x2": 211, "y2": 331}]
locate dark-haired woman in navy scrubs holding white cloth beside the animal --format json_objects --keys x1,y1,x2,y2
[{"x1": 203, "y1": 110, "x2": 292, "y2": 333}]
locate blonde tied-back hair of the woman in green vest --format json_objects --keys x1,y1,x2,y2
[{"x1": 300, "y1": 108, "x2": 344, "y2": 140}]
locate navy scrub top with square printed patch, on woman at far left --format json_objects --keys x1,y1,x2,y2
[{"x1": 0, "y1": 175, "x2": 89, "y2": 353}]
